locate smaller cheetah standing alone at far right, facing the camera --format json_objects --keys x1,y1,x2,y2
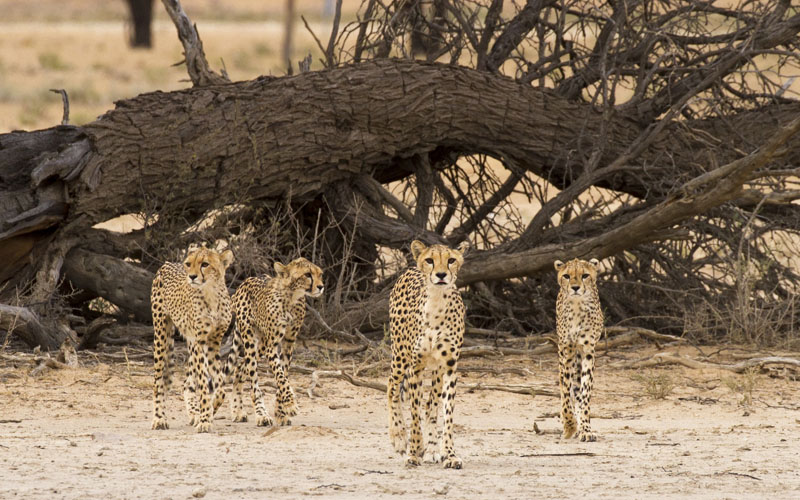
[{"x1": 554, "y1": 259, "x2": 603, "y2": 441}]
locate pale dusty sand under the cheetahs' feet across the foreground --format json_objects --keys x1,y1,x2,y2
[{"x1": 0, "y1": 348, "x2": 800, "y2": 499}]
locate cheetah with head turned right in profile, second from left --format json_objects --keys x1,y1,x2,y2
[{"x1": 225, "y1": 258, "x2": 325, "y2": 426}]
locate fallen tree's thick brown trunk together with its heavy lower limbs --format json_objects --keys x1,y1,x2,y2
[{"x1": 0, "y1": 60, "x2": 800, "y2": 338}]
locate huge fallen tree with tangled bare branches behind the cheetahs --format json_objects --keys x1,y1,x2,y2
[{"x1": 0, "y1": 0, "x2": 800, "y2": 352}]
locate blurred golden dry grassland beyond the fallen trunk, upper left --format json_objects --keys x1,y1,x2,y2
[{"x1": 0, "y1": 0, "x2": 360, "y2": 133}]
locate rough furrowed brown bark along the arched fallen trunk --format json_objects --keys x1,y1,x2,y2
[{"x1": 0, "y1": 61, "x2": 800, "y2": 233}]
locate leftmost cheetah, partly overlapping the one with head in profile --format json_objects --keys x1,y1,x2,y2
[{"x1": 150, "y1": 247, "x2": 233, "y2": 432}]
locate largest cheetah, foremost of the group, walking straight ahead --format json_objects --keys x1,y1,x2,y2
[{"x1": 387, "y1": 240, "x2": 467, "y2": 469}]
